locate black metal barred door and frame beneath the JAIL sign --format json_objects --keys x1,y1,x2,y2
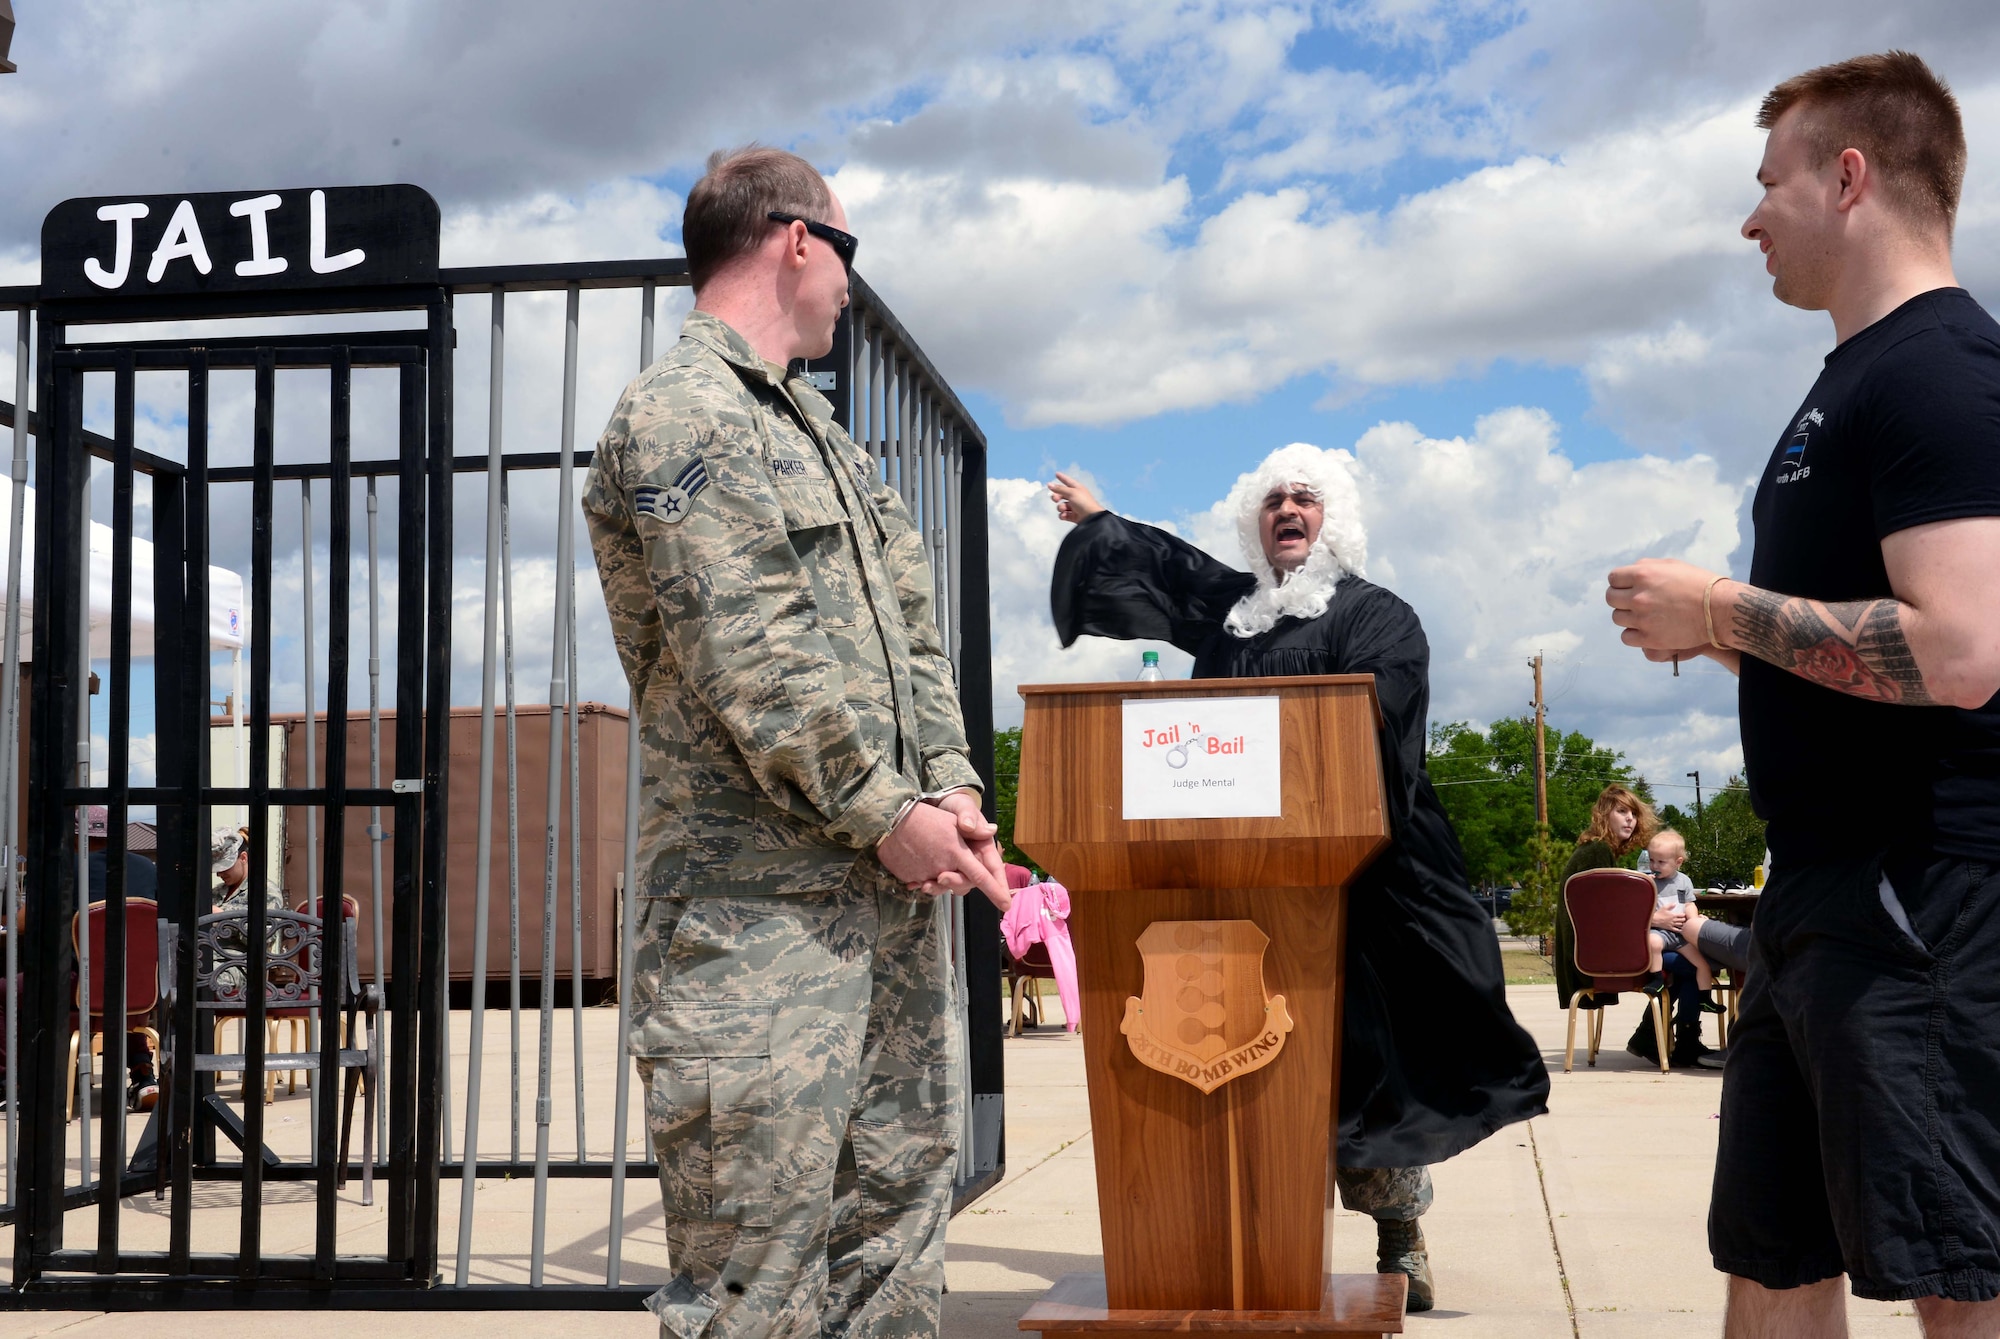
[{"x1": 6, "y1": 277, "x2": 452, "y2": 1307}]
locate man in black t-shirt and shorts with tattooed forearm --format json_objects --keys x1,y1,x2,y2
[{"x1": 1606, "y1": 52, "x2": 2000, "y2": 1335}]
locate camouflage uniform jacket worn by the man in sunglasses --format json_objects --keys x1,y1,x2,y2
[{"x1": 584, "y1": 312, "x2": 980, "y2": 897}]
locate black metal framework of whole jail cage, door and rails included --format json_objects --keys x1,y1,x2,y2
[{"x1": 0, "y1": 260, "x2": 1006, "y2": 1311}]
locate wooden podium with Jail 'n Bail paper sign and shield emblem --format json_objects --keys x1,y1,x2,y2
[{"x1": 1014, "y1": 675, "x2": 1408, "y2": 1339}]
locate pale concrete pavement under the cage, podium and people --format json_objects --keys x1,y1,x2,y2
[{"x1": 0, "y1": 985, "x2": 1918, "y2": 1339}]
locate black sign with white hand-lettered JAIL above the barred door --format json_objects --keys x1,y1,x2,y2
[{"x1": 42, "y1": 186, "x2": 438, "y2": 298}]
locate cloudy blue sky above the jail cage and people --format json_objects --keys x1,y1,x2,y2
[{"x1": 0, "y1": 0, "x2": 2000, "y2": 781}]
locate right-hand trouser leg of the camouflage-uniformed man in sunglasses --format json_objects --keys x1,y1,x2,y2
[{"x1": 822, "y1": 875, "x2": 962, "y2": 1339}]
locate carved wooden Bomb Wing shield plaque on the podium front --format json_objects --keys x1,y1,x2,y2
[{"x1": 1118, "y1": 921, "x2": 1292, "y2": 1093}]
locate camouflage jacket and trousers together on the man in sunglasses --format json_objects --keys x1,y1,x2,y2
[{"x1": 584, "y1": 150, "x2": 980, "y2": 1339}]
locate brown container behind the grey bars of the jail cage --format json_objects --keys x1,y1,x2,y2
[{"x1": 272, "y1": 701, "x2": 626, "y2": 985}]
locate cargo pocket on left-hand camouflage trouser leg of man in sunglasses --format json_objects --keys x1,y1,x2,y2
[{"x1": 630, "y1": 999, "x2": 776, "y2": 1227}]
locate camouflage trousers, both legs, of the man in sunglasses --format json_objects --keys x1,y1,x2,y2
[{"x1": 630, "y1": 861, "x2": 960, "y2": 1339}]
